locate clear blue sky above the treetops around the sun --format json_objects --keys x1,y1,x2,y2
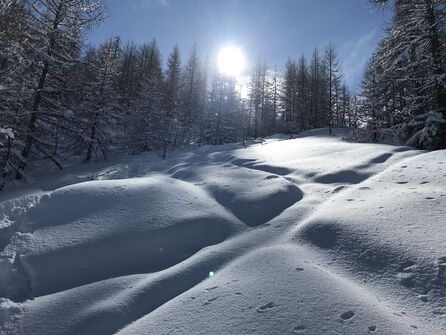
[{"x1": 89, "y1": 0, "x2": 390, "y2": 90}]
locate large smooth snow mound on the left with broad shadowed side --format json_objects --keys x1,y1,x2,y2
[{"x1": 0, "y1": 176, "x2": 244, "y2": 299}]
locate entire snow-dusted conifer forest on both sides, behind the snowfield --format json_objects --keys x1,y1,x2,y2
[{"x1": 0, "y1": 0, "x2": 446, "y2": 188}]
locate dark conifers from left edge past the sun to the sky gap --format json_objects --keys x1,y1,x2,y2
[{"x1": 0, "y1": 0, "x2": 358, "y2": 188}]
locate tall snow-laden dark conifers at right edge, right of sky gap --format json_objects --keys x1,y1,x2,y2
[{"x1": 361, "y1": 0, "x2": 446, "y2": 149}]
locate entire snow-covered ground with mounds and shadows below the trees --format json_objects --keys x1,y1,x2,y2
[{"x1": 0, "y1": 130, "x2": 446, "y2": 335}]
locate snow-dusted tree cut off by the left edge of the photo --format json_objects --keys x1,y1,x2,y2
[{"x1": 0, "y1": 0, "x2": 32, "y2": 186}]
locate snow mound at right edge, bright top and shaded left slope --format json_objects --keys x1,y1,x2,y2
[{"x1": 296, "y1": 151, "x2": 446, "y2": 330}]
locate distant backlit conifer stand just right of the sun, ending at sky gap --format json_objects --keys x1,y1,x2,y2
[{"x1": 254, "y1": 45, "x2": 358, "y2": 137}]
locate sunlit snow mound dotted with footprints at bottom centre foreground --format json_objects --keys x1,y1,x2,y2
[{"x1": 118, "y1": 245, "x2": 420, "y2": 335}]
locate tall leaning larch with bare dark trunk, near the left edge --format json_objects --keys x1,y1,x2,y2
[{"x1": 17, "y1": 0, "x2": 103, "y2": 179}]
